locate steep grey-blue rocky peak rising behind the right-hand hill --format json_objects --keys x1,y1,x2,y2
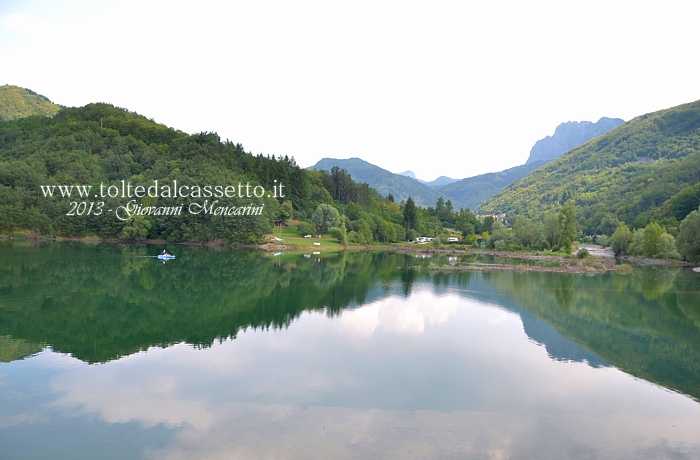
[{"x1": 525, "y1": 117, "x2": 625, "y2": 164}]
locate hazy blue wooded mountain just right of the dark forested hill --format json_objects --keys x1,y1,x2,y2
[{"x1": 307, "y1": 158, "x2": 456, "y2": 209}]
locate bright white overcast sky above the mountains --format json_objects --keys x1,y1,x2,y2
[{"x1": 0, "y1": 0, "x2": 700, "y2": 181}]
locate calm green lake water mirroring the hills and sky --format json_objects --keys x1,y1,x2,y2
[{"x1": 0, "y1": 242, "x2": 700, "y2": 459}]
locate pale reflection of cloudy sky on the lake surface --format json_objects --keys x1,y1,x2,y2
[{"x1": 6, "y1": 292, "x2": 700, "y2": 458}]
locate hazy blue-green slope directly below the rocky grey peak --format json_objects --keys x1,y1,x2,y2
[{"x1": 436, "y1": 161, "x2": 546, "y2": 211}]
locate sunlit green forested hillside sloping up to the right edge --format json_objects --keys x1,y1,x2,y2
[{"x1": 480, "y1": 101, "x2": 700, "y2": 230}]
